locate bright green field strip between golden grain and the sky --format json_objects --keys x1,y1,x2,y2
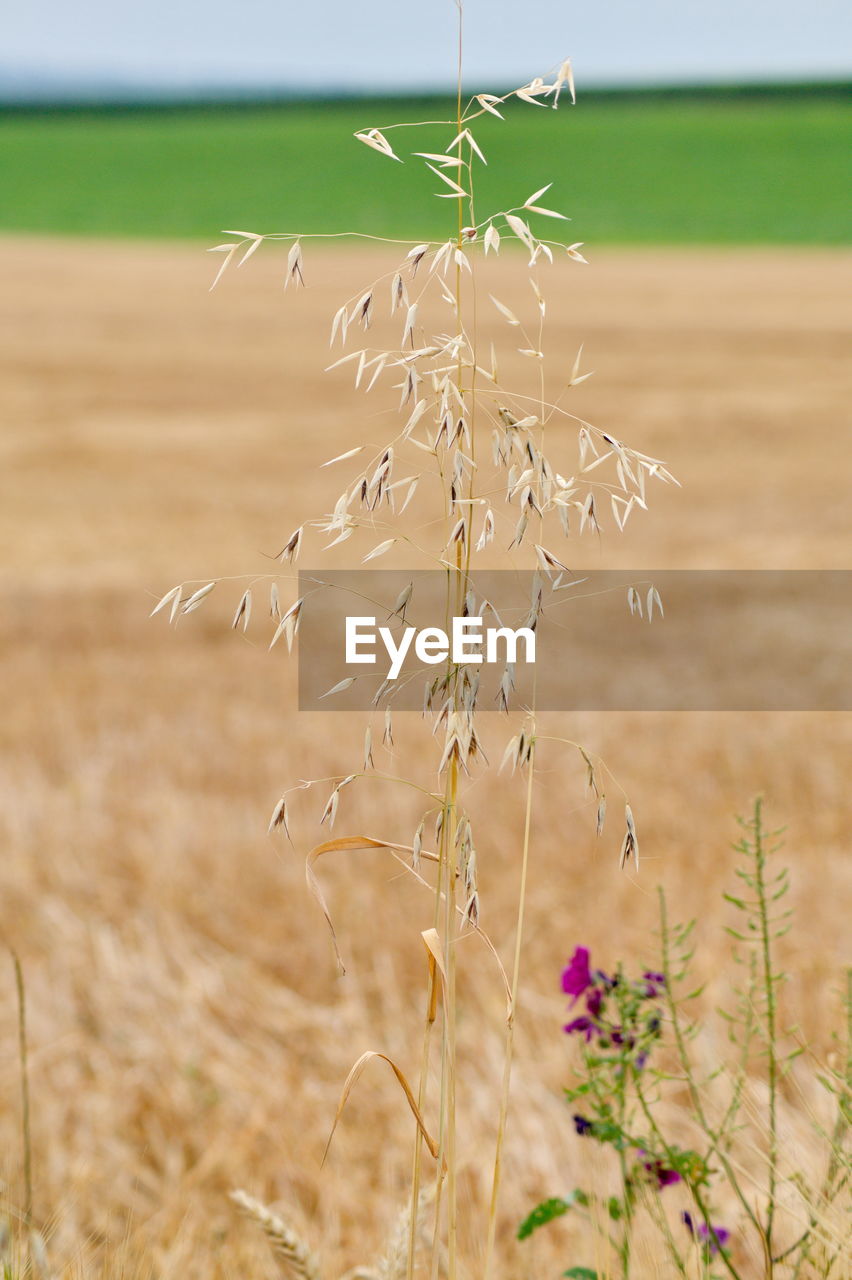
[{"x1": 0, "y1": 93, "x2": 852, "y2": 244}]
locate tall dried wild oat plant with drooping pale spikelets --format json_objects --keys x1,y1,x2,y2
[{"x1": 152, "y1": 5, "x2": 680, "y2": 1280}]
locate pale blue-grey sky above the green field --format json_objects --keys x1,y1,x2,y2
[{"x1": 0, "y1": 0, "x2": 852, "y2": 91}]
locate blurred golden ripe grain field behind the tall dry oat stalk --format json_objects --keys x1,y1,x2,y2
[{"x1": 0, "y1": 238, "x2": 852, "y2": 1280}]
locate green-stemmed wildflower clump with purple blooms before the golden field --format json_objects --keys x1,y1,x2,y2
[{"x1": 518, "y1": 801, "x2": 852, "y2": 1280}]
